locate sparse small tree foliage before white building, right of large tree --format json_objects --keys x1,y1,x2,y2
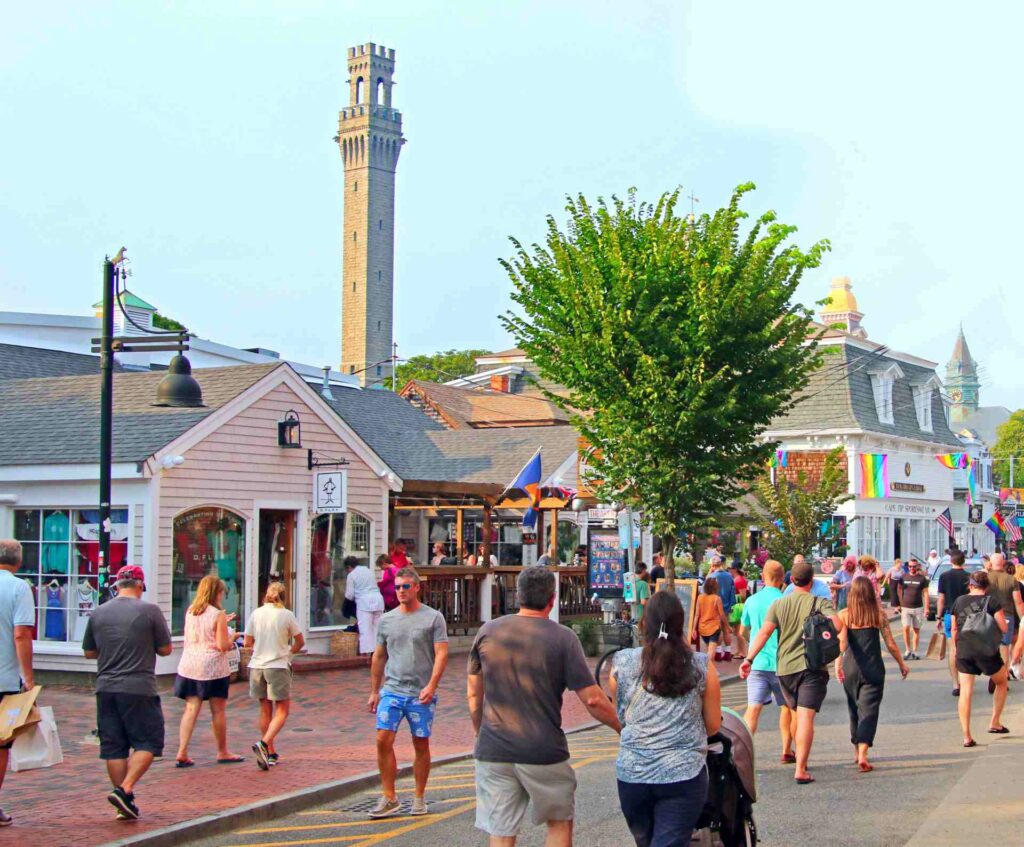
[{"x1": 754, "y1": 447, "x2": 853, "y2": 564}]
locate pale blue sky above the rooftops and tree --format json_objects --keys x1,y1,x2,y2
[{"x1": 0, "y1": 0, "x2": 1024, "y2": 409}]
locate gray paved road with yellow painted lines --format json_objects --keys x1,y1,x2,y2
[{"x1": 186, "y1": 634, "x2": 1024, "y2": 847}]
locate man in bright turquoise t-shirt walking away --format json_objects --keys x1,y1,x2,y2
[{"x1": 740, "y1": 559, "x2": 797, "y2": 765}]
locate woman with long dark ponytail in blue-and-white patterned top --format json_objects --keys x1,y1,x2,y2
[{"x1": 611, "y1": 580, "x2": 722, "y2": 847}]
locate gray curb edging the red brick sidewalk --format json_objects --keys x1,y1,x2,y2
[{"x1": 105, "y1": 675, "x2": 739, "y2": 847}]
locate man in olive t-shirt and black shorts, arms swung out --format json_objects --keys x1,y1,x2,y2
[{"x1": 739, "y1": 561, "x2": 845, "y2": 786}]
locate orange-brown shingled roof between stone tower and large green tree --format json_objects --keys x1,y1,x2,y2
[{"x1": 400, "y1": 379, "x2": 568, "y2": 429}]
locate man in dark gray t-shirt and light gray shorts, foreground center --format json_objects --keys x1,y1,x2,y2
[{"x1": 468, "y1": 567, "x2": 622, "y2": 844}]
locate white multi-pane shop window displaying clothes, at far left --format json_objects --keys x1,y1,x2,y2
[{"x1": 14, "y1": 509, "x2": 128, "y2": 642}]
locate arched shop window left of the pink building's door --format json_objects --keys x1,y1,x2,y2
[{"x1": 171, "y1": 507, "x2": 246, "y2": 635}]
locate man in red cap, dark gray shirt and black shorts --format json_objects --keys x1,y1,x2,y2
[{"x1": 82, "y1": 564, "x2": 171, "y2": 820}]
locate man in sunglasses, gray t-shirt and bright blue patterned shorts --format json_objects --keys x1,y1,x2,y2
[{"x1": 367, "y1": 567, "x2": 447, "y2": 817}]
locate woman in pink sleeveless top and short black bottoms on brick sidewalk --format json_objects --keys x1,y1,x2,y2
[{"x1": 174, "y1": 576, "x2": 245, "y2": 767}]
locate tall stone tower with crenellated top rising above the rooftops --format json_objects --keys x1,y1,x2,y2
[{"x1": 335, "y1": 44, "x2": 406, "y2": 385}]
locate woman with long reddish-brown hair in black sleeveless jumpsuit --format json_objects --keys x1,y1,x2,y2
[{"x1": 836, "y1": 577, "x2": 910, "y2": 773}]
